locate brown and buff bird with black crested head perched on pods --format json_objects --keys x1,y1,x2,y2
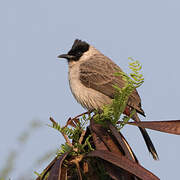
[{"x1": 58, "y1": 39, "x2": 159, "y2": 160}]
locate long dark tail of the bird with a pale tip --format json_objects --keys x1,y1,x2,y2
[{"x1": 133, "y1": 113, "x2": 159, "y2": 160}]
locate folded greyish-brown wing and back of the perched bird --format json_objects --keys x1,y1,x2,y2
[{"x1": 80, "y1": 54, "x2": 144, "y2": 115}]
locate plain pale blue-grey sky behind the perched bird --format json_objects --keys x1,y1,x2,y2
[{"x1": 0, "y1": 0, "x2": 180, "y2": 180}]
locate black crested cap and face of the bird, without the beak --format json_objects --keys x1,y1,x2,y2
[{"x1": 68, "y1": 39, "x2": 89, "y2": 60}]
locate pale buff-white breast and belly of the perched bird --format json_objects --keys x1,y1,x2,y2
[{"x1": 69, "y1": 62, "x2": 112, "y2": 110}]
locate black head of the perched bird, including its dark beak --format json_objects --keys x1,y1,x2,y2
[{"x1": 58, "y1": 39, "x2": 89, "y2": 61}]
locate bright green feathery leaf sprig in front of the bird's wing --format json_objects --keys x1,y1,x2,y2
[{"x1": 94, "y1": 58, "x2": 144, "y2": 128}]
